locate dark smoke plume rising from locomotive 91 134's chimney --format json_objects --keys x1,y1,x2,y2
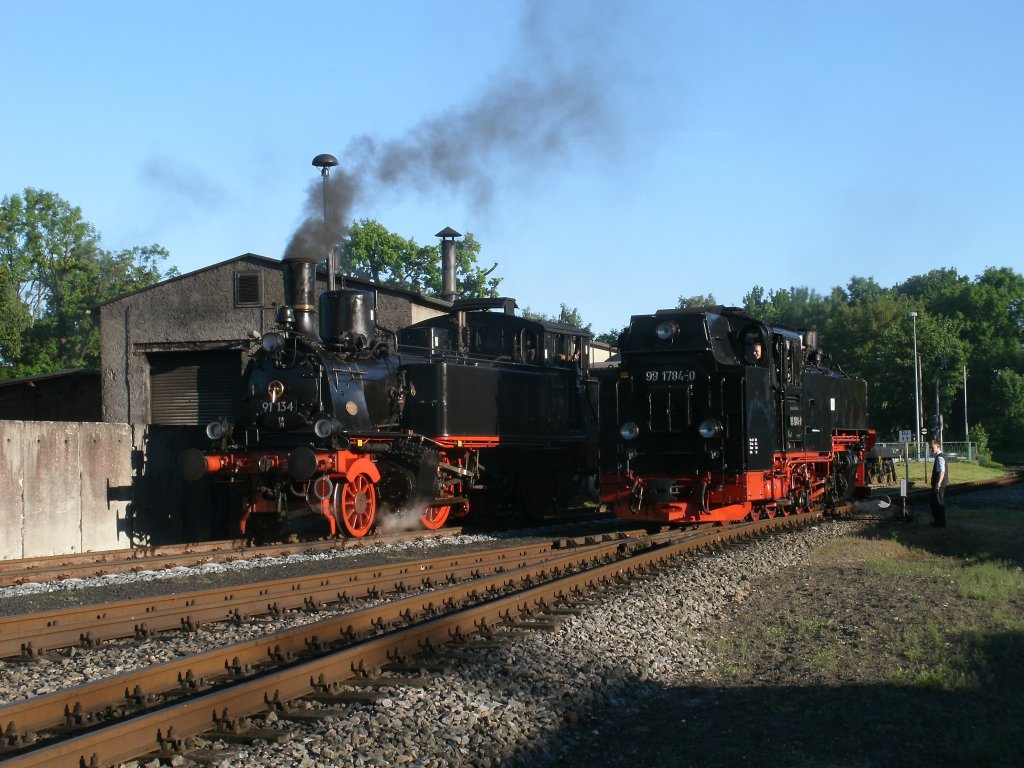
[{"x1": 286, "y1": 2, "x2": 622, "y2": 264}]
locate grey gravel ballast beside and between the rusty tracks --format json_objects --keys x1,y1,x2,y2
[{"x1": 0, "y1": 520, "x2": 864, "y2": 768}]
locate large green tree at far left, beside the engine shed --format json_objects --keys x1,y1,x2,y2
[{"x1": 0, "y1": 187, "x2": 177, "y2": 377}]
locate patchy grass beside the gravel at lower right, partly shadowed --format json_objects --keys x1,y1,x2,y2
[{"x1": 648, "y1": 503, "x2": 1024, "y2": 768}]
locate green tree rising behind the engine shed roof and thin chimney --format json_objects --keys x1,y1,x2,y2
[{"x1": 339, "y1": 219, "x2": 501, "y2": 298}]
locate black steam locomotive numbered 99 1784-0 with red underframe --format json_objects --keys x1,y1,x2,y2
[{"x1": 600, "y1": 306, "x2": 874, "y2": 525}]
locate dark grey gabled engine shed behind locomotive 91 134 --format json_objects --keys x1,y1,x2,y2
[{"x1": 94, "y1": 253, "x2": 447, "y2": 426}]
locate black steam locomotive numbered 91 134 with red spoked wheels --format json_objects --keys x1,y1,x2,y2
[{"x1": 179, "y1": 242, "x2": 597, "y2": 539}]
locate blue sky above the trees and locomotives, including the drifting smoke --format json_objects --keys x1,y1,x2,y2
[{"x1": 0, "y1": 0, "x2": 1024, "y2": 332}]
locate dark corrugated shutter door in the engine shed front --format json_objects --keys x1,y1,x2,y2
[{"x1": 147, "y1": 351, "x2": 242, "y2": 425}]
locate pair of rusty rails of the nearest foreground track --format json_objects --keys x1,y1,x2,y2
[{"x1": 0, "y1": 513, "x2": 820, "y2": 768}]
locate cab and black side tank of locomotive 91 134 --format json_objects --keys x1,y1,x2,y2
[{"x1": 398, "y1": 299, "x2": 598, "y2": 517}]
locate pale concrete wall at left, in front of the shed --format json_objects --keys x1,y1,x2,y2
[{"x1": 0, "y1": 421, "x2": 132, "y2": 559}]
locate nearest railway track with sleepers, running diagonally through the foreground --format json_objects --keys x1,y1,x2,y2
[{"x1": 0, "y1": 513, "x2": 820, "y2": 768}]
